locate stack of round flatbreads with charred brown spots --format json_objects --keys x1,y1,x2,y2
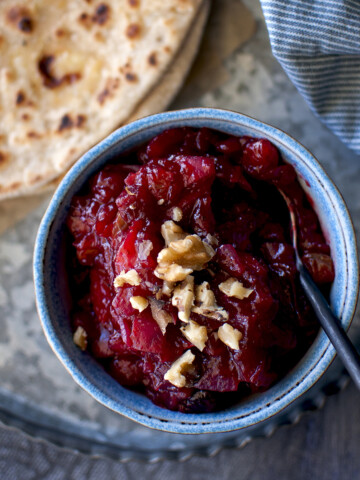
[{"x1": 0, "y1": 0, "x2": 210, "y2": 199}]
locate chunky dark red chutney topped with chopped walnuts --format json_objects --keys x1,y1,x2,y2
[{"x1": 67, "y1": 127, "x2": 334, "y2": 413}]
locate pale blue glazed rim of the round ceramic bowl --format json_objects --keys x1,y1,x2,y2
[{"x1": 33, "y1": 108, "x2": 359, "y2": 434}]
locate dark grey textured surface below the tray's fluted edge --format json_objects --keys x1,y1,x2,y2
[{"x1": 0, "y1": 386, "x2": 360, "y2": 480}]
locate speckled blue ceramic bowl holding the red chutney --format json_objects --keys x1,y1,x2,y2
[{"x1": 34, "y1": 108, "x2": 359, "y2": 433}]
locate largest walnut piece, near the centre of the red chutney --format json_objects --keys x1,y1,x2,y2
[{"x1": 154, "y1": 220, "x2": 215, "y2": 282}]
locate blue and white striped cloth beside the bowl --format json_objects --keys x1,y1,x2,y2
[{"x1": 260, "y1": 0, "x2": 360, "y2": 154}]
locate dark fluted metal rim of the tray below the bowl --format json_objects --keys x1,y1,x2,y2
[{"x1": 0, "y1": 366, "x2": 350, "y2": 464}]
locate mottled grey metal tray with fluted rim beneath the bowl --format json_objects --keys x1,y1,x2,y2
[{"x1": 0, "y1": 0, "x2": 360, "y2": 462}]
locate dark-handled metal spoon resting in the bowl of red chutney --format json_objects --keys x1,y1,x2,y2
[{"x1": 279, "y1": 189, "x2": 360, "y2": 390}]
